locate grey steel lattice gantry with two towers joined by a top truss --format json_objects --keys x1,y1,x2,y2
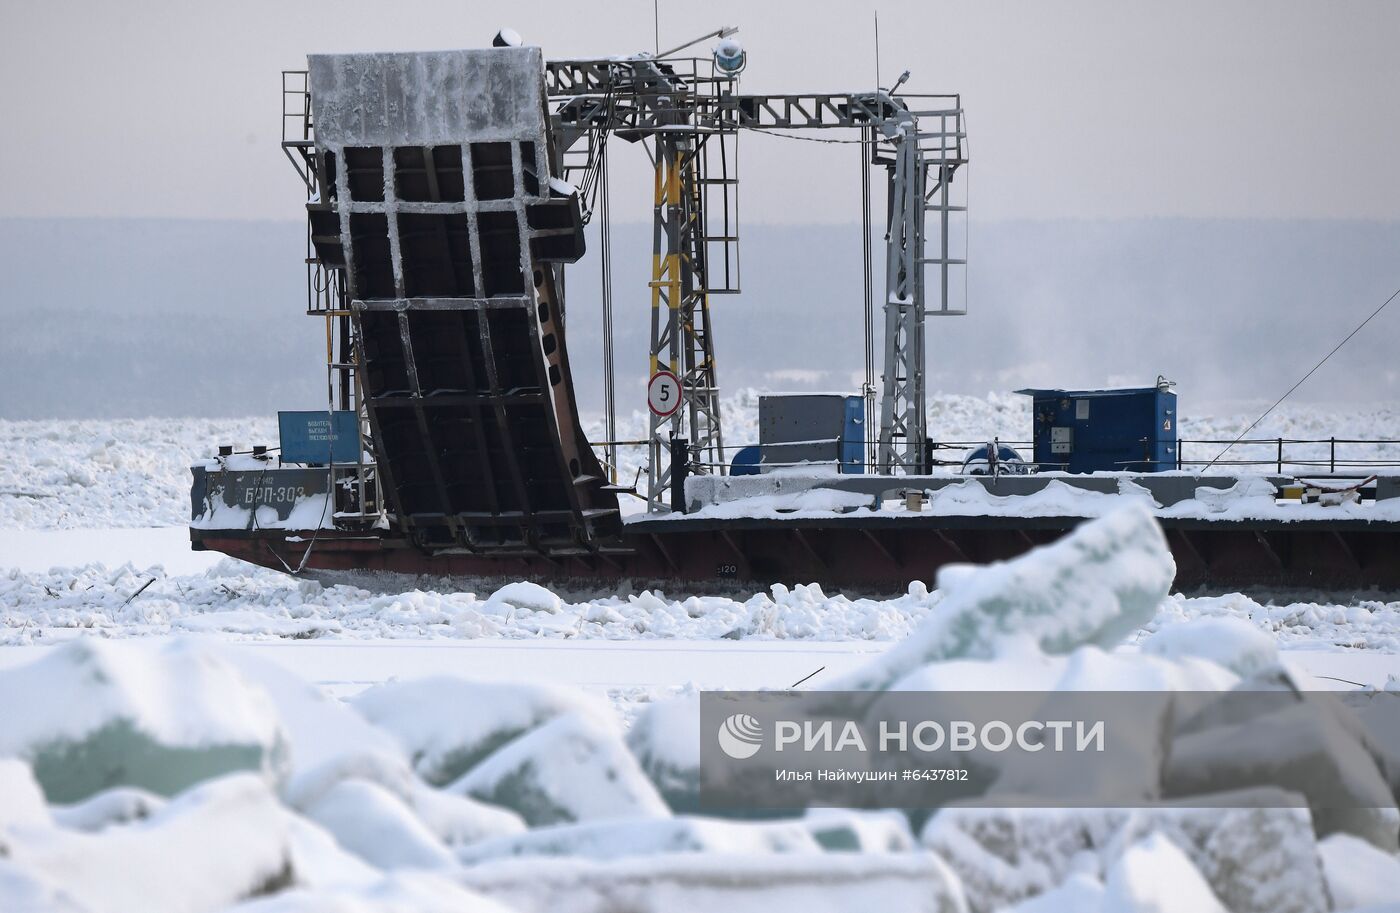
[{"x1": 545, "y1": 56, "x2": 967, "y2": 511}]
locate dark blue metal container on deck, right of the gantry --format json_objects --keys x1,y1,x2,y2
[{"x1": 1016, "y1": 386, "x2": 1177, "y2": 472}]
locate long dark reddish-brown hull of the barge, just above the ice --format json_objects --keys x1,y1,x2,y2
[{"x1": 190, "y1": 517, "x2": 1400, "y2": 592}]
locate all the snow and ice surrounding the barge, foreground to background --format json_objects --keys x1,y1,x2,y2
[{"x1": 0, "y1": 392, "x2": 1400, "y2": 913}]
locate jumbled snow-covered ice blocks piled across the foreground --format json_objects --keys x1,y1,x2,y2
[{"x1": 0, "y1": 506, "x2": 1400, "y2": 913}]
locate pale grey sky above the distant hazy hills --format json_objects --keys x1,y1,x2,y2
[{"x1": 0, "y1": 0, "x2": 1400, "y2": 223}]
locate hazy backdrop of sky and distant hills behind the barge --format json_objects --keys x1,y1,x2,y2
[{"x1": 0, "y1": 0, "x2": 1400, "y2": 417}]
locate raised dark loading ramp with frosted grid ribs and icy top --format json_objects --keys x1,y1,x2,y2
[{"x1": 308, "y1": 48, "x2": 620, "y2": 557}]
